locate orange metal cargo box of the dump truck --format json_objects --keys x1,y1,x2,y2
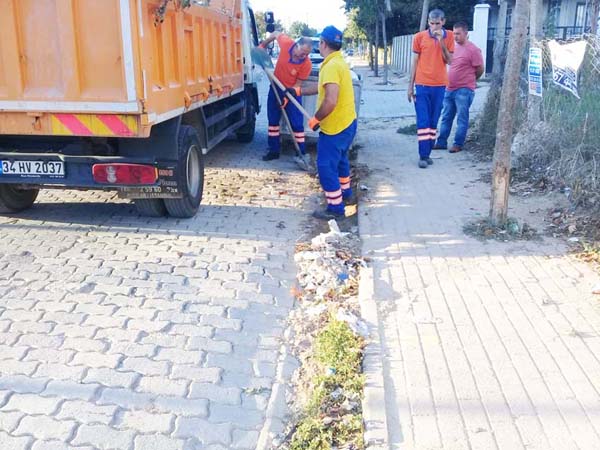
[{"x1": 0, "y1": 0, "x2": 244, "y2": 137}]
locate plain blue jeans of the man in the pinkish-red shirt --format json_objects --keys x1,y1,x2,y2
[{"x1": 436, "y1": 88, "x2": 475, "y2": 147}]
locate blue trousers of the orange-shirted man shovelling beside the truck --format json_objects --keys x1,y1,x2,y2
[{"x1": 267, "y1": 86, "x2": 306, "y2": 154}]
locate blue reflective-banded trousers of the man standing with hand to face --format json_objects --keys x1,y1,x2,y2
[{"x1": 415, "y1": 84, "x2": 446, "y2": 159}]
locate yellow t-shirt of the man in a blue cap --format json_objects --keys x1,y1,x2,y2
[{"x1": 317, "y1": 51, "x2": 356, "y2": 134}]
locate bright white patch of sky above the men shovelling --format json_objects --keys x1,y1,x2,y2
[{"x1": 250, "y1": 0, "x2": 346, "y2": 31}]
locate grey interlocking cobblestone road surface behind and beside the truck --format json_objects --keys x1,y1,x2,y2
[{"x1": 0, "y1": 79, "x2": 315, "y2": 450}]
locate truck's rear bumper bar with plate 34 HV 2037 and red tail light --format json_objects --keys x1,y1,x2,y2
[{"x1": 0, "y1": 152, "x2": 183, "y2": 199}]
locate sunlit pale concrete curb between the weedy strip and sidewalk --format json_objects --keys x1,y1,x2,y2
[{"x1": 358, "y1": 267, "x2": 389, "y2": 450}]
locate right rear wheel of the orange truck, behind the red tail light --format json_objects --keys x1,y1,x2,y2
[{"x1": 164, "y1": 125, "x2": 204, "y2": 218}]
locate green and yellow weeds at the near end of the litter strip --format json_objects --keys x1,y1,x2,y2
[{"x1": 290, "y1": 318, "x2": 364, "y2": 450}]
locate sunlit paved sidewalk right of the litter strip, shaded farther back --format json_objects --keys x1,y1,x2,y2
[{"x1": 359, "y1": 65, "x2": 600, "y2": 450}]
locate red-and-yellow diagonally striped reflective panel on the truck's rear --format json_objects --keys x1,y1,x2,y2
[{"x1": 51, "y1": 114, "x2": 138, "y2": 137}]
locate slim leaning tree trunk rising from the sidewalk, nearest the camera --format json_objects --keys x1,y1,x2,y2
[{"x1": 490, "y1": 0, "x2": 529, "y2": 226}]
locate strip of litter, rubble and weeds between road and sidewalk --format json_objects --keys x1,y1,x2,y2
[{"x1": 272, "y1": 220, "x2": 368, "y2": 449}]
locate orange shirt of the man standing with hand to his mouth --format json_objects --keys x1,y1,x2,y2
[{"x1": 413, "y1": 30, "x2": 454, "y2": 86}]
